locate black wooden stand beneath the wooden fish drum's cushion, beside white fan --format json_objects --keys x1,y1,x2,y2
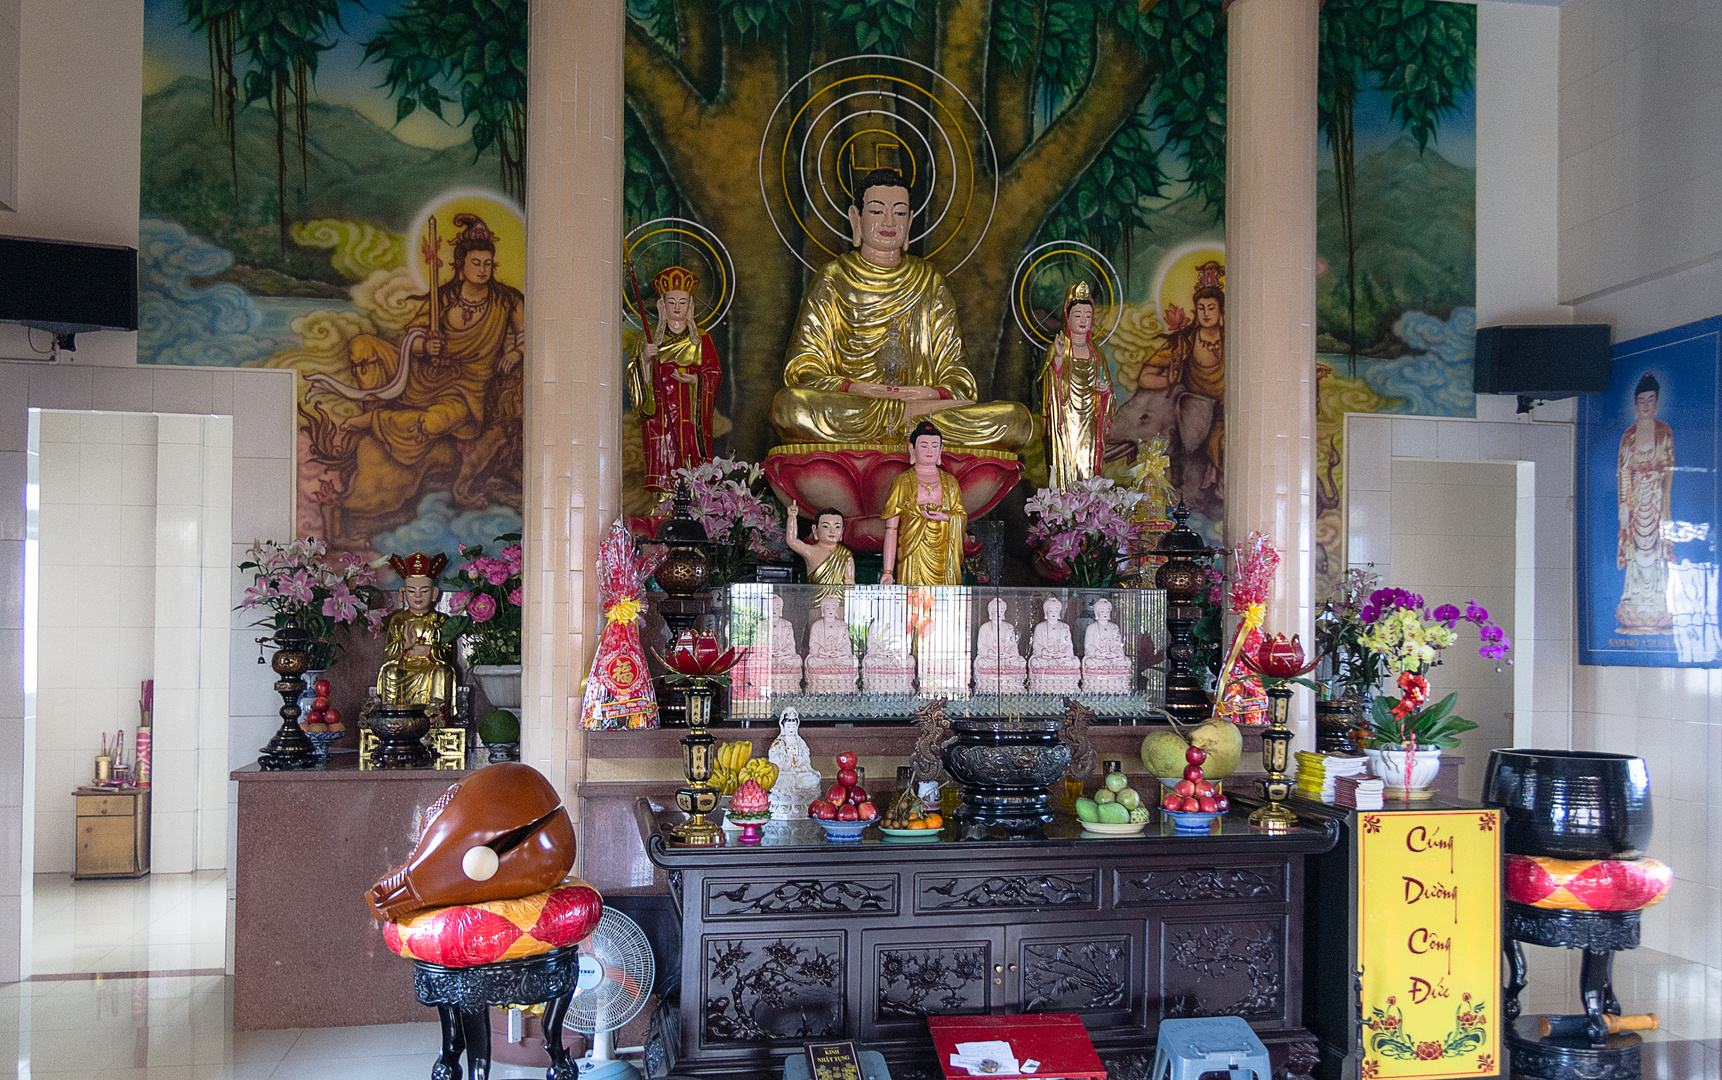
[{"x1": 413, "y1": 947, "x2": 580, "y2": 1080}]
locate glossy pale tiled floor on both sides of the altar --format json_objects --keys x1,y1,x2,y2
[{"x1": 0, "y1": 873, "x2": 1722, "y2": 1080}]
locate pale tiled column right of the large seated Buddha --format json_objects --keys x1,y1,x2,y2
[{"x1": 1226, "y1": 0, "x2": 1321, "y2": 746}]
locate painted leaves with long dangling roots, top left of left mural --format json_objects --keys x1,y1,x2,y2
[{"x1": 181, "y1": 0, "x2": 343, "y2": 251}]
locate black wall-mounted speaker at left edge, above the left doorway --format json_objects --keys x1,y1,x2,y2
[{"x1": 0, "y1": 236, "x2": 138, "y2": 334}]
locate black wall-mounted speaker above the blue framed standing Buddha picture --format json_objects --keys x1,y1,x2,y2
[{"x1": 1472, "y1": 324, "x2": 1614, "y2": 400}]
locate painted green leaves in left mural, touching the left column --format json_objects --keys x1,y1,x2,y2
[{"x1": 365, "y1": 0, "x2": 527, "y2": 200}]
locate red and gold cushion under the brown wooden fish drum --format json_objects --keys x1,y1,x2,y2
[{"x1": 382, "y1": 877, "x2": 604, "y2": 968}]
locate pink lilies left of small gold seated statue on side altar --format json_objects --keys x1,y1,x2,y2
[{"x1": 236, "y1": 536, "x2": 389, "y2": 672}]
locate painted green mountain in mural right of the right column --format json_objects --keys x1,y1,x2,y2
[{"x1": 1316, "y1": 138, "x2": 1477, "y2": 357}]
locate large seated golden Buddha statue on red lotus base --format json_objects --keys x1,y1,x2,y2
[{"x1": 771, "y1": 169, "x2": 1033, "y2": 450}]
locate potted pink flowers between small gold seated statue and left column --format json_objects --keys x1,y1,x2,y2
[{"x1": 443, "y1": 532, "x2": 522, "y2": 713}]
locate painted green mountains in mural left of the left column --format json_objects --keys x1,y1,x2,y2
[{"x1": 141, "y1": 79, "x2": 498, "y2": 298}]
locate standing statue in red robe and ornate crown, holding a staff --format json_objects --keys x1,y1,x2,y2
[{"x1": 629, "y1": 267, "x2": 723, "y2": 494}]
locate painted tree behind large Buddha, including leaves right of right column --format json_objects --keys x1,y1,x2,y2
[{"x1": 625, "y1": 0, "x2": 1474, "y2": 458}]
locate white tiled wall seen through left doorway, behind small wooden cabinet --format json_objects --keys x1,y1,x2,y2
[{"x1": 34, "y1": 410, "x2": 232, "y2": 873}]
